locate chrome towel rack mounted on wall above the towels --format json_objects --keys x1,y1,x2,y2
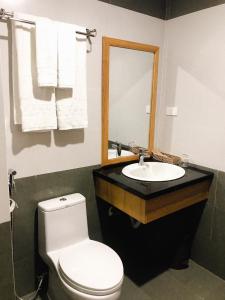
[{"x1": 0, "y1": 8, "x2": 97, "y2": 52}]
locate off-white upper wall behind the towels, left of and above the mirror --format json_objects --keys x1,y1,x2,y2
[{"x1": 0, "y1": 0, "x2": 164, "y2": 177}]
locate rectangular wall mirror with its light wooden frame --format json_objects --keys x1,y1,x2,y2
[{"x1": 102, "y1": 37, "x2": 159, "y2": 165}]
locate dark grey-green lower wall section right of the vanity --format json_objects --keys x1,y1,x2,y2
[{"x1": 192, "y1": 167, "x2": 225, "y2": 279}]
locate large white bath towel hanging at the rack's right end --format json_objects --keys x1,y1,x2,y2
[{"x1": 56, "y1": 26, "x2": 88, "y2": 130}]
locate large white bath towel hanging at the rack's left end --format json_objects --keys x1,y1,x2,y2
[{"x1": 12, "y1": 15, "x2": 57, "y2": 132}]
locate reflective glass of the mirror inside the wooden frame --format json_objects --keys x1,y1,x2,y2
[{"x1": 108, "y1": 47, "x2": 154, "y2": 159}]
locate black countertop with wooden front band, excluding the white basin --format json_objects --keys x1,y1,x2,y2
[{"x1": 94, "y1": 165, "x2": 213, "y2": 224}]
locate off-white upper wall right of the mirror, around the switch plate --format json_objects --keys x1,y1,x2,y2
[{"x1": 157, "y1": 5, "x2": 225, "y2": 171}]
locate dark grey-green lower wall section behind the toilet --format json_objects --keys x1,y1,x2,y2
[{"x1": 13, "y1": 166, "x2": 101, "y2": 296}]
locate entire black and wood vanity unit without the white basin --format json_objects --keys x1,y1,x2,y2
[{"x1": 93, "y1": 163, "x2": 213, "y2": 278}]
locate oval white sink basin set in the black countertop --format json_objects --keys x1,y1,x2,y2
[{"x1": 122, "y1": 162, "x2": 185, "y2": 181}]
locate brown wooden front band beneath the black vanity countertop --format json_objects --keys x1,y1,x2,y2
[{"x1": 95, "y1": 177, "x2": 211, "y2": 224}]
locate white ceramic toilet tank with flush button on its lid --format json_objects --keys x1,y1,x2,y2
[{"x1": 38, "y1": 193, "x2": 89, "y2": 256}]
